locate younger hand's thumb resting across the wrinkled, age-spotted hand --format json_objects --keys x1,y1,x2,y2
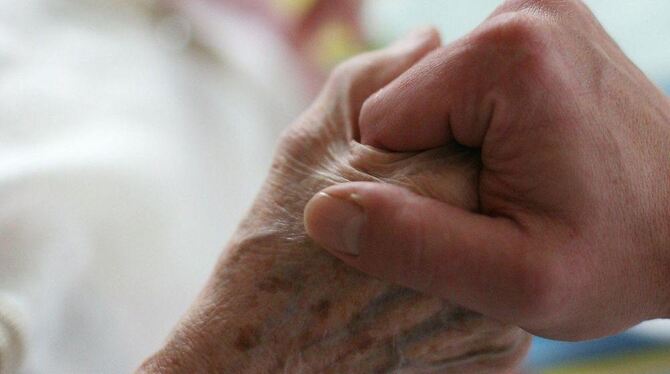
[{"x1": 305, "y1": 182, "x2": 538, "y2": 321}]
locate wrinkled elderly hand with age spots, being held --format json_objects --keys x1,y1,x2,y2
[{"x1": 138, "y1": 30, "x2": 530, "y2": 373}]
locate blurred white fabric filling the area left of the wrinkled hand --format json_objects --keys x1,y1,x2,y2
[{"x1": 0, "y1": 0, "x2": 305, "y2": 374}]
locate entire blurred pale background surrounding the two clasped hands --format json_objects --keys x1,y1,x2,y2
[{"x1": 0, "y1": 0, "x2": 670, "y2": 374}]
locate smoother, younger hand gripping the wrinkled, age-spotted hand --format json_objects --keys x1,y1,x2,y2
[{"x1": 306, "y1": 0, "x2": 670, "y2": 340}]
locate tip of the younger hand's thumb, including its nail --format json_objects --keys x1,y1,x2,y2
[{"x1": 305, "y1": 192, "x2": 365, "y2": 256}]
